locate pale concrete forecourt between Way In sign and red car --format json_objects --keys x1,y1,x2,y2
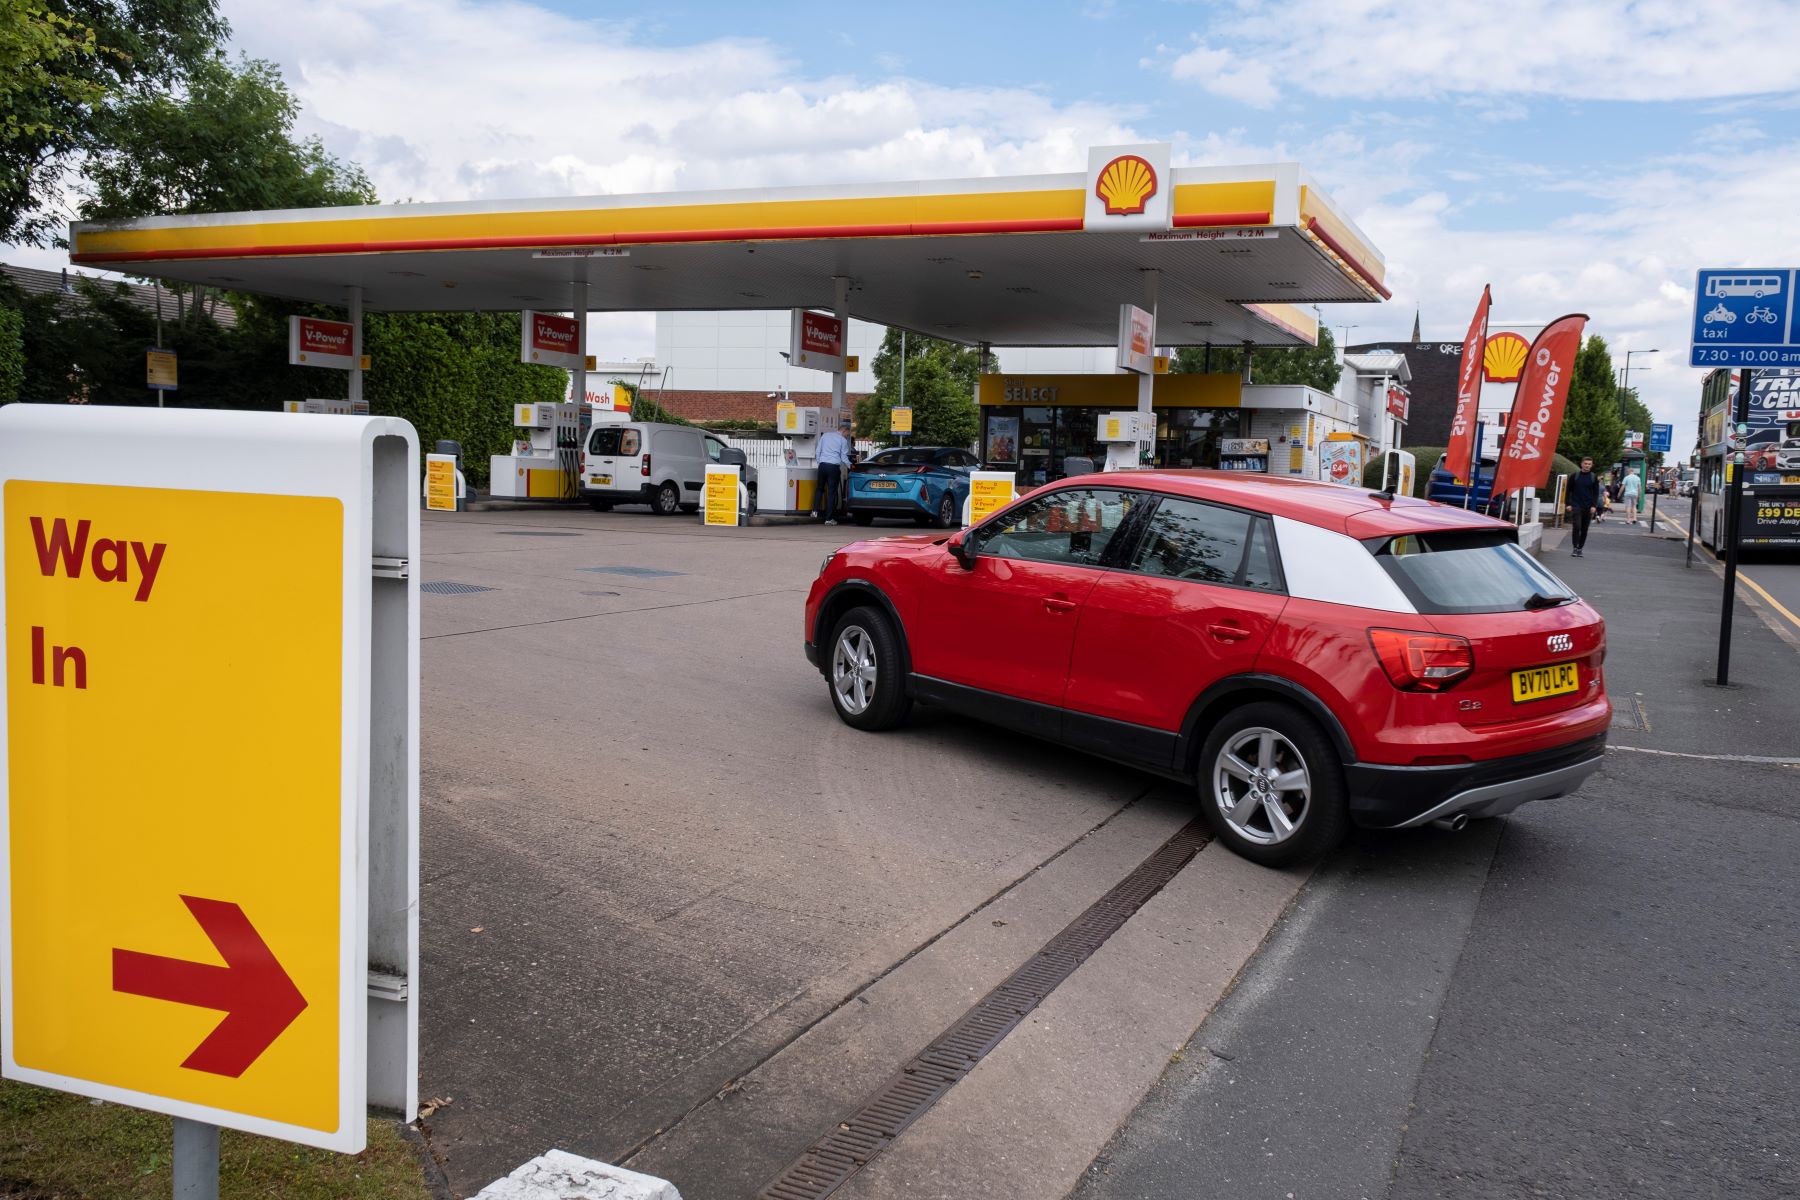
[{"x1": 405, "y1": 509, "x2": 1305, "y2": 1200}]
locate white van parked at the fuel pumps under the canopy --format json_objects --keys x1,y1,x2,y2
[{"x1": 581, "y1": 421, "x2": 756, "y2": 516}]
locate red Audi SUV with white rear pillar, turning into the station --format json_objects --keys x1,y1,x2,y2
[{"x1": 806, "y1": 471, "x2": 1611, "y2": 865}]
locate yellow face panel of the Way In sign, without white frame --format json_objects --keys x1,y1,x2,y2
[{"x1": 4, "y1": 480, "x2": 344, "y2": 1132}]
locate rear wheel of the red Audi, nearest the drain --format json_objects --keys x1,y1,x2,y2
[{"x1": 1197, "y1": 702, "x2": 1350, "y2": 867}]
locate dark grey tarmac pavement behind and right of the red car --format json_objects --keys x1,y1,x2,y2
[{"x1": 1075, "y1": 510, "x2": 1800, "y2": 1200}]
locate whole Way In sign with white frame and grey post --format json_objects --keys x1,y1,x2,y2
[{"x1": 0, "y1": 405, "x2": 419, "y2": 1195}]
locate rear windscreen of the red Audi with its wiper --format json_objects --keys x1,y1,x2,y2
[{"x1": 1368, "y1": 529, "x2": 1575, "y2": 613}]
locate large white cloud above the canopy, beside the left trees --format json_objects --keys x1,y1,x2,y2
[{"x1": 225, "y1": 0, "x2": 1138, "y2": 200}]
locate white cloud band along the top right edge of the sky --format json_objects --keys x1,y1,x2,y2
[{"x1": 1156, "y1": 0, "x2": 1800, "y2": 101}]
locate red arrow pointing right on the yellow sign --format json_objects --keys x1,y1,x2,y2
[{"x1": 113, "y1": 896, "x2": 306, "y2": 1079}]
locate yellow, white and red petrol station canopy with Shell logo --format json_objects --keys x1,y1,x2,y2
[{"x1": 70, "y1": 146, "x2": 1388, "y2": 345}]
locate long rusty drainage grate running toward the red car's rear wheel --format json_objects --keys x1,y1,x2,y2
[{"x1": 756, "y1": 817, "x2": 1210, "y2": 1200}]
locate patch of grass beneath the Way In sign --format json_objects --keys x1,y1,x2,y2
[{"x1": 0, "y1": 1079, "x2": 430, "y2": 1200}]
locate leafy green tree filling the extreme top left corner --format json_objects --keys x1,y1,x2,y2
[{"x1": 0, "y1": 0, "x2": 229, "y2": 245}]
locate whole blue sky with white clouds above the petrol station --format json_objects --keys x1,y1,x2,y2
[{"x1": 31, "y1": 0, "x2": 1800, "y2": 448}]
